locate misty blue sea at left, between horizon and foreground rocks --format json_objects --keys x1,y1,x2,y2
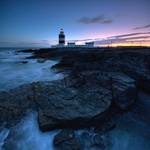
[{"x1": 0, "y1": 48, "x2": 63, "y2": 91}]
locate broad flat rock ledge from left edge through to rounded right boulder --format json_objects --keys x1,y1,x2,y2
[{"x1": 0, "y1": 72, "x2": 136, "y2": 131}]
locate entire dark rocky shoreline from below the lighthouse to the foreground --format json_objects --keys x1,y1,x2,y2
[{"x1": 0, "y1": 47, "x2": 150, "y2": 150}]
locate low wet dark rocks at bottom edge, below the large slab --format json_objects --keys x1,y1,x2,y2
[{"x1": 54, "y1": 129, "x2": 111, "y2": 150}]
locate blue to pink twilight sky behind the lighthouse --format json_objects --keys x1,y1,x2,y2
[{"x1": 0, "y1": 0, "x2": 150, "y2": 47}]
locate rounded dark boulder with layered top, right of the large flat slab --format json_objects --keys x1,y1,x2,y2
[{"x1": 112, "y1": 73, "x2": 137, "y2": 110}]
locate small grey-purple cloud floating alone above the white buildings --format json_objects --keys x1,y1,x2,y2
[{"x1": 78, "y1": 15, "x2": 113, "y2": 24}]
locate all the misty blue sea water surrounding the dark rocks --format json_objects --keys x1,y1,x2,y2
[{"x1": 0, "y1": 48, "x2": 150, "y2": 150}]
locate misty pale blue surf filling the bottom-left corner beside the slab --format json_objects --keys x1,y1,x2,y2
[{"x1": 0, "y1": 112, "x2": 58, "y2": 150}]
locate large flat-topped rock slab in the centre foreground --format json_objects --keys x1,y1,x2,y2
[{"x1": 36, "y1": 79, "x2": 112, "y2": 131}]
